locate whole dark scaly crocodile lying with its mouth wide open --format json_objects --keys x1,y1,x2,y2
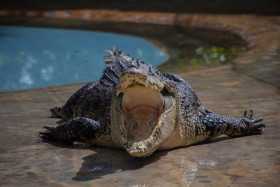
[{"x1": 40, "y1": 49, "x2": 265, "y2": 157}]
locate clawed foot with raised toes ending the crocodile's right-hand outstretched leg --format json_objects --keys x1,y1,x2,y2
[{"x1": 242, "y1": 110, "x2": 265, "y2": 135}]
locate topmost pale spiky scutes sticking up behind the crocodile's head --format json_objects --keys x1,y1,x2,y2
[{"x1": 104, "y1": 48, "x2": 132, "y2": 65}]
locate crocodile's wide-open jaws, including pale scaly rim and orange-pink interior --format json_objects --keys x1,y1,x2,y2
[{"x1": 114, "y1": 69, "x2": 176, "y2": 157}]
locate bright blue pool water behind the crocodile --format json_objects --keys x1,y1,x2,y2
[{"x1": 0, "y1": 26, "x2": 168, "y2": 91}]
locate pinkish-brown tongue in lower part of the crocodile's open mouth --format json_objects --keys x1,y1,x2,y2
[{"x1": 125, "y1": 106, "x2": 159, "y2": 141}]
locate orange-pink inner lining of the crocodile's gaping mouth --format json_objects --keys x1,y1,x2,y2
[{"x1": 122, "y1": 85, "x2": 164, "y2": 141}]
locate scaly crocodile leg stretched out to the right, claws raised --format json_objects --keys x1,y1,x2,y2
[{"x1": 201, "y1": 109, "x2": 265, "y2": 138}]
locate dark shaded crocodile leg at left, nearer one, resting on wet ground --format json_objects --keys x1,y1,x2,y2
[{"x1": 40, "y1": 117, "x2": 102, "y2": 147}]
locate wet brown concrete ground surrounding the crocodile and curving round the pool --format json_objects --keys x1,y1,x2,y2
[{"x1": 0, "y1": 10, "x2": 280, "y2": 186}]
